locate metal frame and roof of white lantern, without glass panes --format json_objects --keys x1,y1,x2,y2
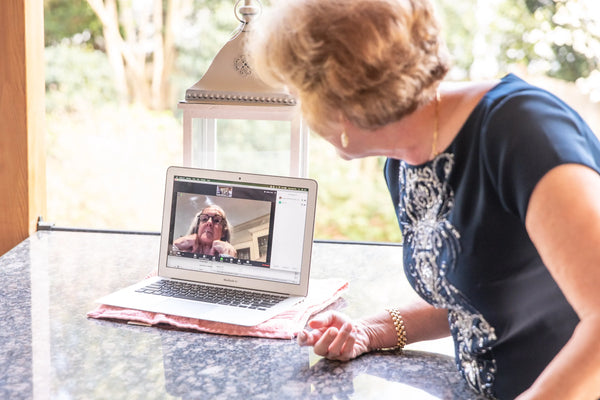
[{"x1": 178, "y1": 0, "x2": 309, "y2": 177}]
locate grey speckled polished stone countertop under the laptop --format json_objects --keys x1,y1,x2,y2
[{"x1": 0, "y1": 231, "x2": 486, "y2": 399}]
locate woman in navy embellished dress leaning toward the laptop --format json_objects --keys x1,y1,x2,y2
[{"x1": 248, "y1": 0, "x2": 600, "y2": 399}]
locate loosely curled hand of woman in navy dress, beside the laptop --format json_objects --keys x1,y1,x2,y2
[{"x1": 298, "y1": 311, "x2": 371, "y2": 361}]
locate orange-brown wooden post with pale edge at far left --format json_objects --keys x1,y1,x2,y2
[{"x1": 0, "y1": 0, "x2": 46, "y2": 255}]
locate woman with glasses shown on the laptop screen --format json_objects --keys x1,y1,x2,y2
[{"x1": 173, "y1": 204, "x2": 237, "y2": 257}]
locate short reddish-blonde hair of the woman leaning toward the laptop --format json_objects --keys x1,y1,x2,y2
[{"x1": 247, "y1": 0, "x2": 449, "y2": 131}]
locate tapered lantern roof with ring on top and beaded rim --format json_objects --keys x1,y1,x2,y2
[{"x1": 185, "y1": 0, "x2": 296, "y2": 106}]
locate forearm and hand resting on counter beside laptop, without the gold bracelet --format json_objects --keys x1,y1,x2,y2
[{"x1": 298, "y1": 300, "x2": 450, "y2": 361}]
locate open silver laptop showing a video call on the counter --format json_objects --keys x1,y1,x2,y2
[{"x1": 97, "y1": 167, "x2": 317, "y2": 326}]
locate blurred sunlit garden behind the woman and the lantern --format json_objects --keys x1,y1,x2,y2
[{"x1": 44, "y1": 0, "x2": 600, "y2": 242}]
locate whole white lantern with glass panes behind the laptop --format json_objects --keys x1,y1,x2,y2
[{"x1": 179, "y1": 0, "x2": 309, "y2": 177}]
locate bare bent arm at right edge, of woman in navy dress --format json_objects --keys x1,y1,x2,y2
[{"x1": 519, "y1": 164, "x2": 600, "y2": 400}]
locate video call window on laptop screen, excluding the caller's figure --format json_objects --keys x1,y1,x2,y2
[{"x1": 169, "y1": 180, "x2": 277, "y2": 268}]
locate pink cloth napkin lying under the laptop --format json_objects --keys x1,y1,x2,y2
[{"x1": 87, "y1": 279, "x2": 348, "y2": 339}]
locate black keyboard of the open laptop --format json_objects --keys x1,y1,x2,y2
[{"x1": 136, "y1": 280, "x2": 287, "y2": 310}]
